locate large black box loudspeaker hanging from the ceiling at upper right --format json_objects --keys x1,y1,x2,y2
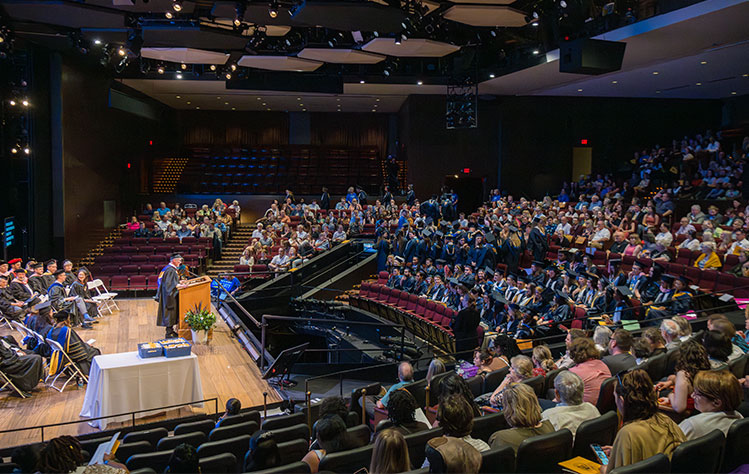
[{"x1": 559, "y1": 38, "x2": 627, "y2": 75}]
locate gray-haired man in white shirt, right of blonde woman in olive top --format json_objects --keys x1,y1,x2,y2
[{"x1": 541, "y1": 370, "x2": 601, "y2": 435}]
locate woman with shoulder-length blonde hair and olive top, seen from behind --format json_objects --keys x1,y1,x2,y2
[{"x1": 489, "y1": 383, "x2": 554, "y2": 452}]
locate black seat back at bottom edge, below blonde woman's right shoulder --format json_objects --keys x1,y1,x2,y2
[{"x1": 515, "y1": 428, "x2": 572, "y2": 473}]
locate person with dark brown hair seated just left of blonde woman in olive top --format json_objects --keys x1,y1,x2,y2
[{"x1": 422, "y1": 395, "x2": 491, "y2": 472}]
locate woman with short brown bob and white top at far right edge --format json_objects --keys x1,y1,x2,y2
[{"x1": 679, "y1": 370, "x2": 743, "y2": 440}]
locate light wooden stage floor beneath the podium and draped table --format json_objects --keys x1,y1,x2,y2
[{"x1": 0, "y1": 298, "x2": 281, "y2": 448}]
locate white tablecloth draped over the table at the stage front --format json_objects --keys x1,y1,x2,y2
[{"x1": 81, "y1": 352, "x2": 203, "y2": 429}]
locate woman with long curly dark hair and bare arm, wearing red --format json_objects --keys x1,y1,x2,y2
[{"x1": 655, "y1": 341, "x2": 710, "y2": 413}]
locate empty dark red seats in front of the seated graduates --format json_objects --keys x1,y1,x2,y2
[{"x1": 349, "y1": 282, "x2": 462, "y2": 352}]
